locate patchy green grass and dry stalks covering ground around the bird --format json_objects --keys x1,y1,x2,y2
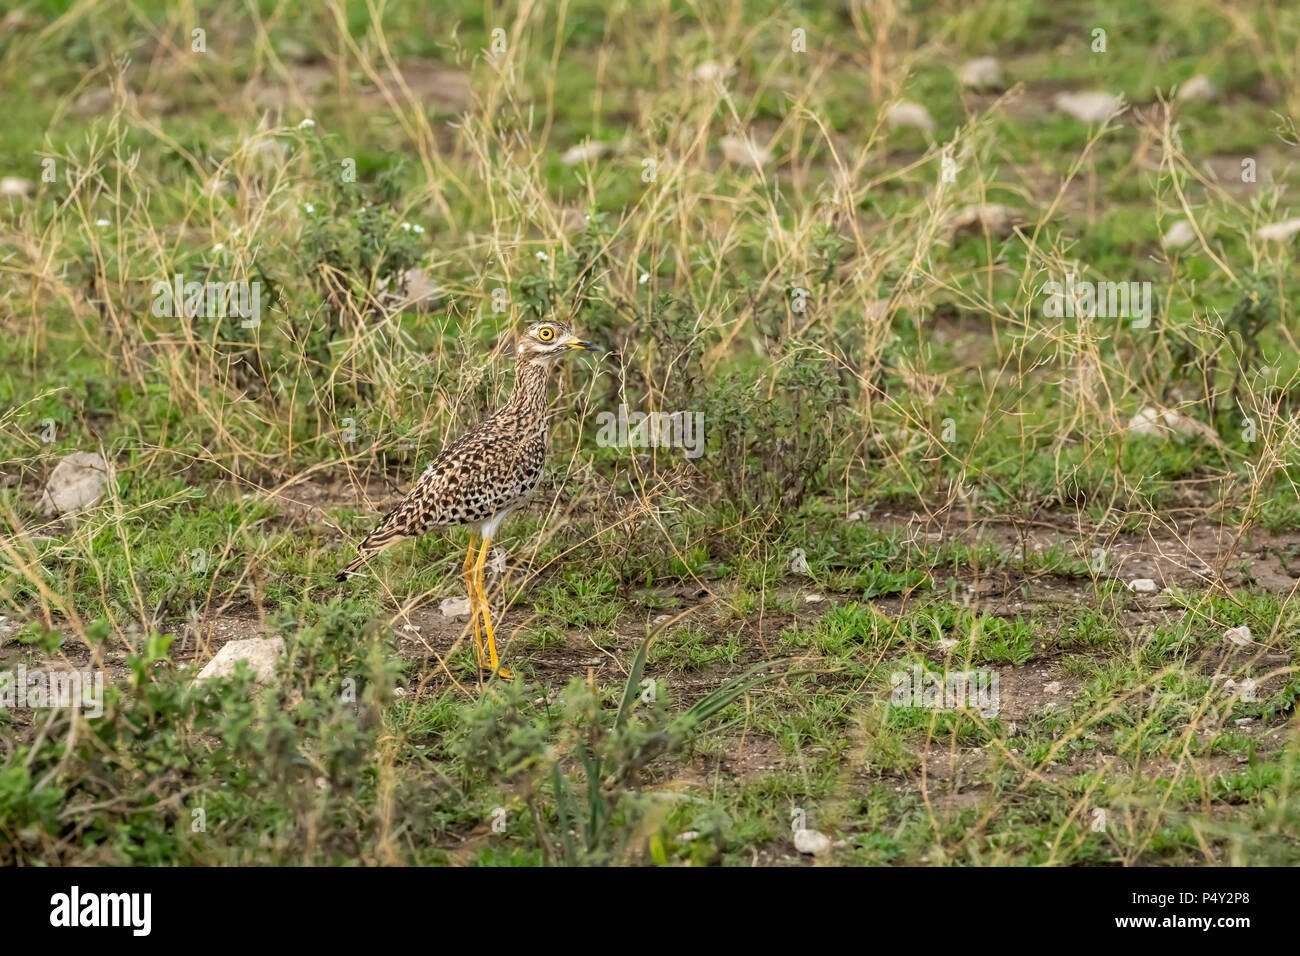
[{"x1": 0, "y1": 0, "x2": 1300, "y2": 865}]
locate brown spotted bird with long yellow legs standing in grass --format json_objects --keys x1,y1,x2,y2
[{"x1": 338, "y1": 321, "x2": 595, "y2": 672}]
